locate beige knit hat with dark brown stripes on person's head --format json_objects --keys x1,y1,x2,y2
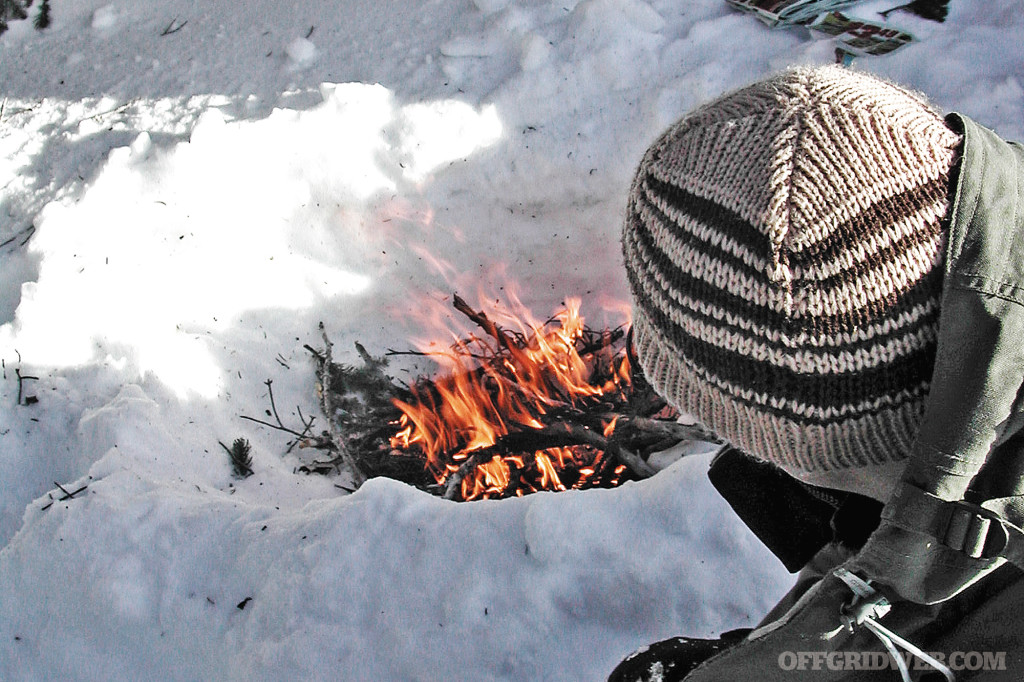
[{"x1": 623, "y1": 67, "x2": 959, "y2": 479}]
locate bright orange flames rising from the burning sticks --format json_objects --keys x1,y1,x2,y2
[{"x1": 391, "y1": 296, "x2": 630, "y2": 500}]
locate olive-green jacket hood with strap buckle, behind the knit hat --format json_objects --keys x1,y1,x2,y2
[{"x1": 855, "y1": 114, "x2": 1024, "y2": 603}]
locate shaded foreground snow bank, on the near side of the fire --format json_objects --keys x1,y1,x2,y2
[{"x1": 0, "y1": 446, "x2": 776, "y2": 680}]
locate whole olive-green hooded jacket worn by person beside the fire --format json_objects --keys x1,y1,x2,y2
[{"x1": 686, "y1": 115, "x2": 1024, "y2": 682}]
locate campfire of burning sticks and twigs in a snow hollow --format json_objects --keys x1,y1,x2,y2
[{"x1": 299, "y1": 286, "x2": 713, "y2": 501}]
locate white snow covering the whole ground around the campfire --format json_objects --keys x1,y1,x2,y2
[{"x1": 0, "y1": 0, "x2": 1024, "y2": 680}]
